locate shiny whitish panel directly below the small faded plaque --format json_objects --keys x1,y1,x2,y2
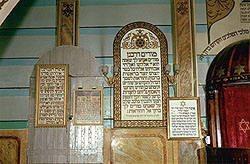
[{"x1": 69, "y1": 125, "x2": 103, "y2": 163}]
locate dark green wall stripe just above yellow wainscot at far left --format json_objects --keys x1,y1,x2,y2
[{"x1": 0, "y1": 120, "x2": 28, "y2": 129}]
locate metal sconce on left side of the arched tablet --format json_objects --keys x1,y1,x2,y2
[{"x1": 100, "y1": 65, "x2": 118, "y2": 86}]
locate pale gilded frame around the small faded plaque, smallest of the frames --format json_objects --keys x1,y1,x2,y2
[{"x1": 73, "y1": 89, "x2": 103, "y2": 125}]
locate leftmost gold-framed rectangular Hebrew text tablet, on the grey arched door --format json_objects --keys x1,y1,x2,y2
[{"x1": 35, "y1": 64, "x2": 68, "y2": 127}]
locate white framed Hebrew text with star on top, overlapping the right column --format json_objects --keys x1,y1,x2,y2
[{"x1": 168, "y1": 97, "x2": 200, "y2": 139}]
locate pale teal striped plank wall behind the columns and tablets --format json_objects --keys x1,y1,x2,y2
[{"x1": 0, "y1": 0, "x2": 213, "y2": 129}]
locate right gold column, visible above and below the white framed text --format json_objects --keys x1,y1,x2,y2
[{"x1": 172, "y1": 0, "x2": 197, "y2": 163}]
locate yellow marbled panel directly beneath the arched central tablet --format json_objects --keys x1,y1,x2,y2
[{"x1": 111, "y1": 128, "x2": 167, "y2": 164}]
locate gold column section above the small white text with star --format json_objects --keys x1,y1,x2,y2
[{"x1": 173, "y1": 0, "x2": 197, "y2": 97}]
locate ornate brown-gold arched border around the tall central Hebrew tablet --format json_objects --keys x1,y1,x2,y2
[{"x1": 113, "y1": 22, "x2": 168, "y2": 127}]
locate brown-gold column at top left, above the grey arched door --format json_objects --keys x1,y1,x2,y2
[{"x1": 57, "y1": 0, "x2": 79, "y2": 46}]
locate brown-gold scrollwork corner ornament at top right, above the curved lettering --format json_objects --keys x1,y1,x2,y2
[{"x1": 207, "y1": 0, "x2": 235, "y2": 28}]
